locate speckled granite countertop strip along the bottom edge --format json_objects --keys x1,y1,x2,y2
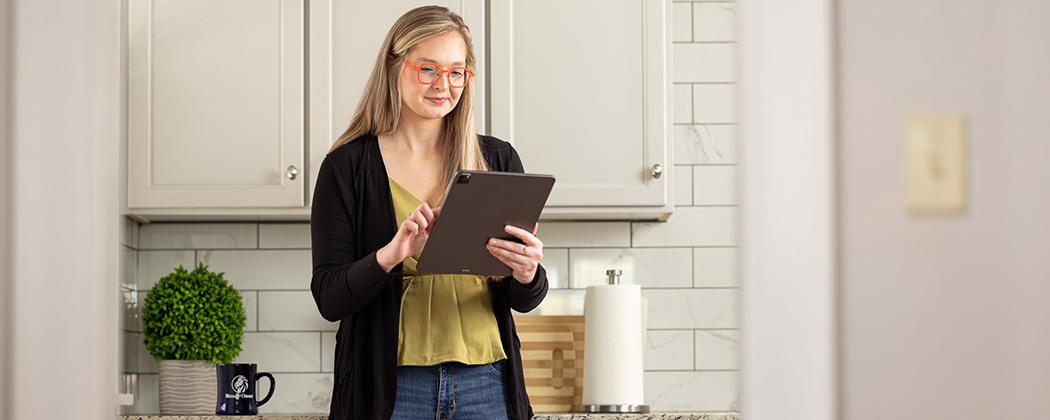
[{"x1": 118, "y1": 413, "x2": 740, "y2": 420}]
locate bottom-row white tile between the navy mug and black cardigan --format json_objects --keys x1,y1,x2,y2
[{"x1": 256, "y1": 373, "x2": 333, "y2": 415}]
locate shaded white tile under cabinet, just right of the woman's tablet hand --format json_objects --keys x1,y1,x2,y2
[{"x1": 537, "y1": 222, "x2": 631, "y2": 248}]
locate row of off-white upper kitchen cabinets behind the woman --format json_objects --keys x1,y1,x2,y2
[{"x1": 120, "y1": 0, "x2": 673, "y2": 221}]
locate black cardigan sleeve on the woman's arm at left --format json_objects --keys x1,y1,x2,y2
[{"x1": 310, "y1": 156, "x2": 391, "y2": 322}]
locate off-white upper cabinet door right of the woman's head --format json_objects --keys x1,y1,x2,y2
[{"x1": 489, "y1": 0, "x2": 672, "y2": 207}]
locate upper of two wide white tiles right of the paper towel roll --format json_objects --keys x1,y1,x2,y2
[{"x1": 642, "y1": 289, "x2": 737, "y2": 330}]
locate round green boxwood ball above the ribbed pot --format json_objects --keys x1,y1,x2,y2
[{"x1": 142, "y1": 264, "x2": 246, "y2": 363}]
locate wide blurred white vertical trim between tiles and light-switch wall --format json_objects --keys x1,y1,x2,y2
[{"x1": 738, "y1": 0, "x2": 838, "y2": 420}]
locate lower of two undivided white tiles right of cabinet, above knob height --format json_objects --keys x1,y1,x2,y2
[{"x1": 674, "y1": 124, "x2": 736, "y2": 165}]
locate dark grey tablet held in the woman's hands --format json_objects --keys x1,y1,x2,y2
[{"x1": 416, "y1": 170, "x2": 554, "y2": 276}]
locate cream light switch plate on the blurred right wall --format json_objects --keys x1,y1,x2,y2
[{"x1": 904, "y1": 114, "x2": 967, "y2": 214}]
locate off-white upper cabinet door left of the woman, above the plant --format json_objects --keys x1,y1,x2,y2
[{"x1": 127, "y1": 0, "x2": 307, "y2": 209}]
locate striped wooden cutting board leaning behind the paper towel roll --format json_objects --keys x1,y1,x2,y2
[{"x1": 515, "y1": 315, "x2": 584, "y2": 413}]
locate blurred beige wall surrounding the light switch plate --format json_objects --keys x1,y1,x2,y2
[{"x1": 838, "y1": 0, "x2": 1050, "y2": 420}]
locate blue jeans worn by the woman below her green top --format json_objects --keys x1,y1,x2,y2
[{"x1": 391, "y1": 359, "x2": 507, "y2": 420}]
